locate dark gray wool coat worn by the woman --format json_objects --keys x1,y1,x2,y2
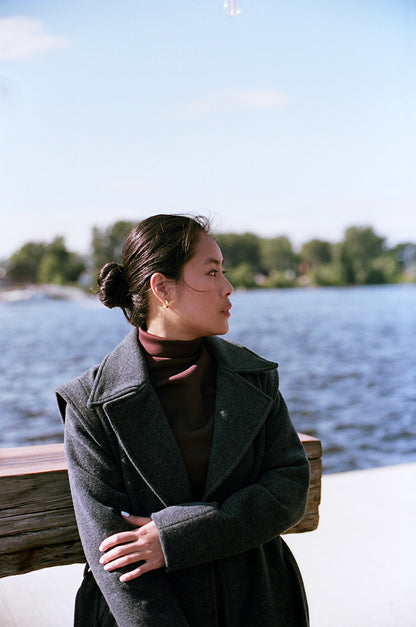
[{"x1": 57, "y1": 329, "x2": 309, "y2": 627}]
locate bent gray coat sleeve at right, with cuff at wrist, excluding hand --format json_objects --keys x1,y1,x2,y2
[{"x1": 152, "y1": 371, "x2": 309, "y2": 571}]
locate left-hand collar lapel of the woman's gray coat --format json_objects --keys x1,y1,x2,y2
[{"x1": 89, "y1": 330, "x2": 193, "y2": 506}]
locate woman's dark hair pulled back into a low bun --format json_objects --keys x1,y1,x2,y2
[{"x1": 98, "y1": 214, "x2": 210, "y2": 326}]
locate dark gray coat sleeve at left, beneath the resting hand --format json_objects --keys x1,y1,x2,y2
[{"x1": 58, "y1": 382, "x2": 188, "y2": 627}]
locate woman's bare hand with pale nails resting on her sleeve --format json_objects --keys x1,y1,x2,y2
[{"x1": 99, "y1": 512, "x2": 165, "y2": 582}]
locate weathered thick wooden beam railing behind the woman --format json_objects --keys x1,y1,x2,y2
[{"x1": 0, "y1": 434, "x2": 322, "y2": 577}]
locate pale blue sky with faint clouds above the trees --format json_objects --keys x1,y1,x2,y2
[{"x1": 0, "y1": 0, "x2": 416, "y2": 258}]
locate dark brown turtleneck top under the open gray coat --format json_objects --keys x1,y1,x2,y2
[{"x1": 139, "y1": 329, "x2": 216, "y2": 498}]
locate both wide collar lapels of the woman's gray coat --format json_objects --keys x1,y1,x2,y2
[{"x1": 88, "y1": 329, "x2": 277, "y2": 506}]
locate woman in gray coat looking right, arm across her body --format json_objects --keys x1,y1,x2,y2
[{"x1": 58, "y1": 215, "x2": 309, "y2": 627}]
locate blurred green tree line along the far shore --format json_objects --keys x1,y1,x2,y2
[{"x1": 2, "y1": 221, "x2": 416, "y2": 288}]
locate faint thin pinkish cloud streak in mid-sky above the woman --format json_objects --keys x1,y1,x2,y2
[{"x1": 178, "y1": 89, "x2": 288, "y2": 115}]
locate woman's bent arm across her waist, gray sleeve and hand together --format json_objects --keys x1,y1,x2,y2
[{"x1": 93, "y1": 408, "x2": 309, "y2": 582}]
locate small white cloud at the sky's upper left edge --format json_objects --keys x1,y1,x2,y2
[{"x1": 0, "y1": 16, "x2": 68, "y2": 60}]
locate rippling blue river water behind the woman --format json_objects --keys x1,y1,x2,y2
[{"x1": 0, "y1": 285, "x2": 416, "y2": 473}]
